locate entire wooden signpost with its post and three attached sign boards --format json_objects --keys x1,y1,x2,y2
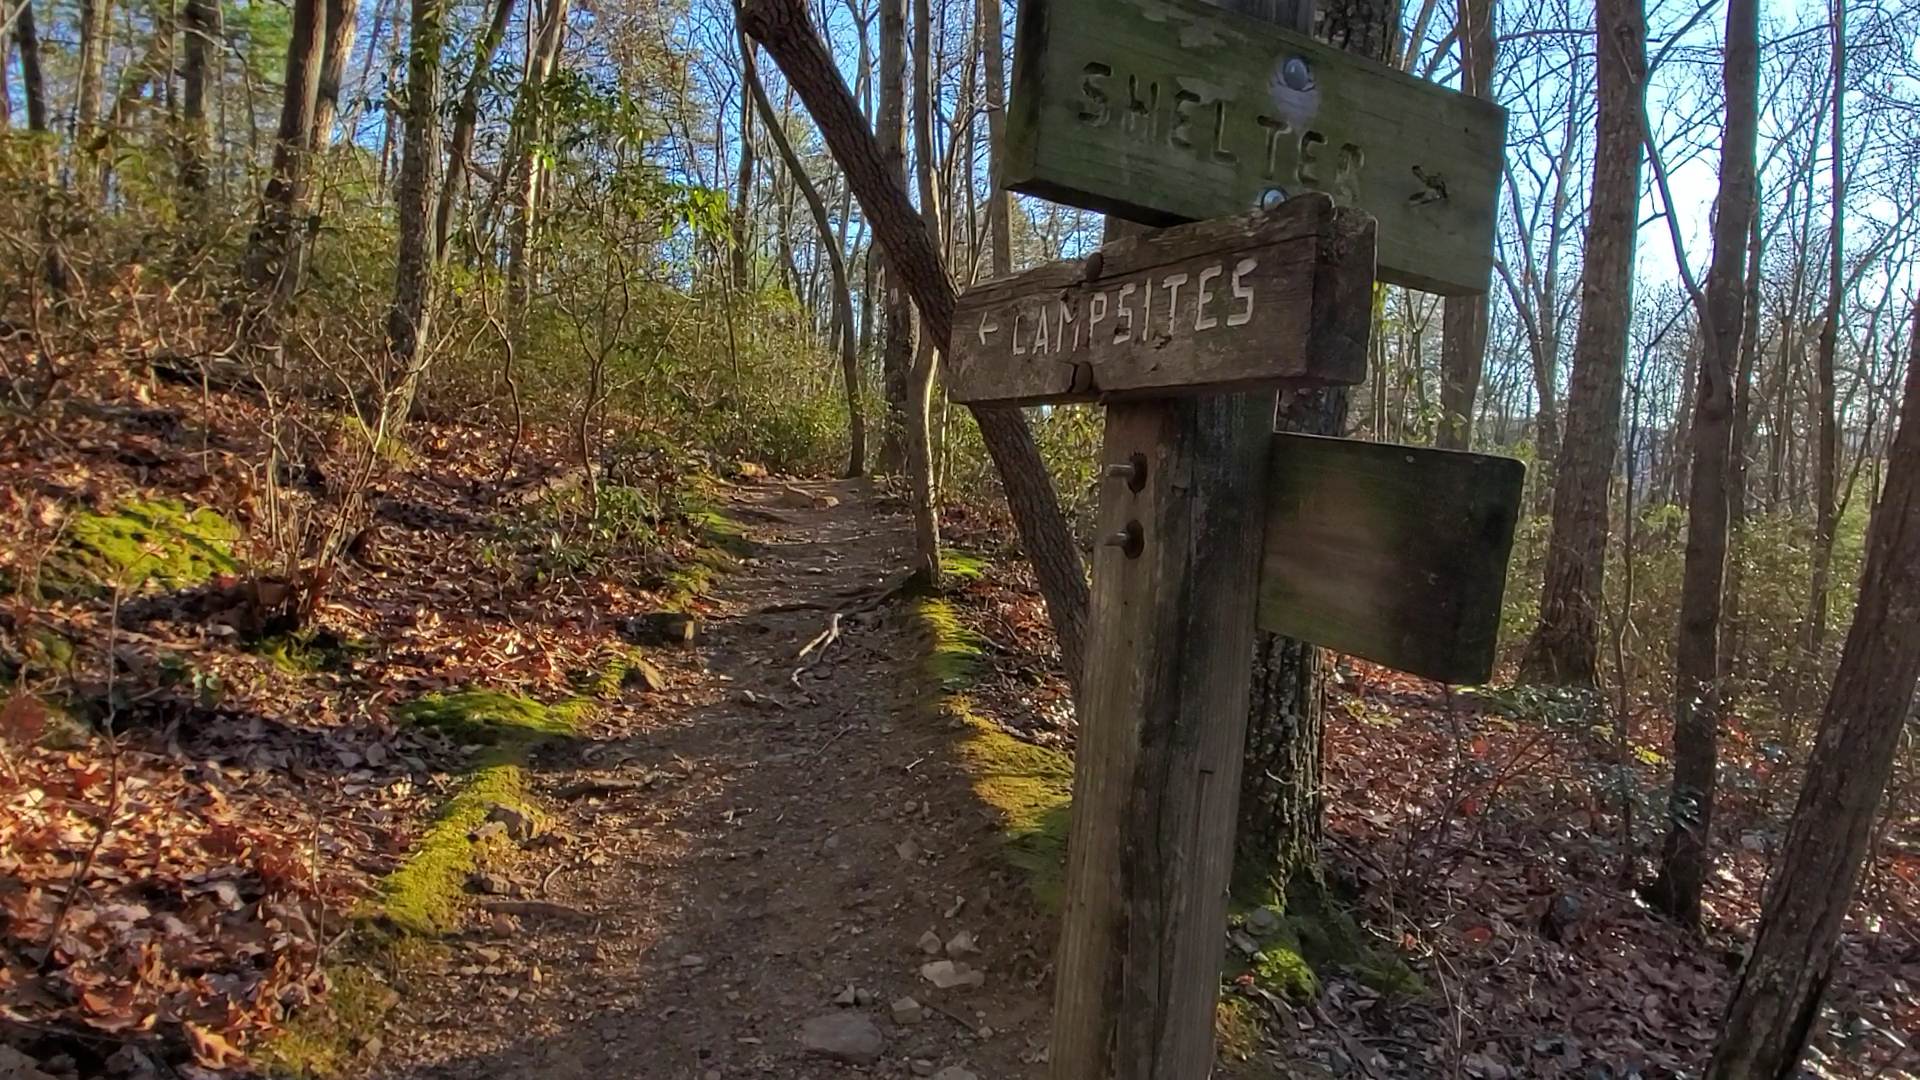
[{"x1": 948, "y1": 0, "x2": 1521, "y2": 1080}]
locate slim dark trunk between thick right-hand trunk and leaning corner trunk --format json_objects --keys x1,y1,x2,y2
[{"x1": 1651, "y1": 0, "x2": 1761, "y2": 928}]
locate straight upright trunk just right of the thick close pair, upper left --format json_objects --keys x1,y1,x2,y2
[{"x1": 380, "y1": 0, "x2": 445, "y2": 401}]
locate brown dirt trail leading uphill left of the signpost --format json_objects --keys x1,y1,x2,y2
[{"x1": 372, "y1": 482, "x2": 1050, "y2": 1080}]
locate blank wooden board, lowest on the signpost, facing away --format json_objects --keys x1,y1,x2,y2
[{"x1": 1260, "y1": 434, "x2": 1526, "y2": 682}]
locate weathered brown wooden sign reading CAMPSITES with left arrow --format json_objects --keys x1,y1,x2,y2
[{"x1": 947, "y1": 194, "x2": 1375, "y2": 405}]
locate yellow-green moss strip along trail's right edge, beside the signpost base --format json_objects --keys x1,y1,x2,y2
[{"x1": 914, "y1": 572, "x2": 1073, "y2": 911}]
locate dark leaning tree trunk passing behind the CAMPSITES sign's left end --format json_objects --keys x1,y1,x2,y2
[{"x1": 741, "y1": 0, "x2": 1087, "y2": 688}]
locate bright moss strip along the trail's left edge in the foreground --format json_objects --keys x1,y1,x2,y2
[{"x1": 257, "y1": 688, "x2": 591, "y2": 1080}]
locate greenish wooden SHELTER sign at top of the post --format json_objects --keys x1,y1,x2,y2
[{"x1": 1006, "y1": 0, "x2": 1507, "y2": 294}]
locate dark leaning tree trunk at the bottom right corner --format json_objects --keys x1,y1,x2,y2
[{"x1": 1707, "y1": 295, "x2": 1920, "y2": 1080}]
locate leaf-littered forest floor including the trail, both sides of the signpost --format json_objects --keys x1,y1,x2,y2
[{"x1": 0, "y1": 367, "x2": 1920, "y2": 1080}]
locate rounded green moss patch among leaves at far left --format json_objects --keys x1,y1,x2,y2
[{"x1": 40, "y1": 500, "x2": 240, "y2": 596}]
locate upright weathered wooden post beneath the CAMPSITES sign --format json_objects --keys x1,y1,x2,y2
[{"x1": 1048, "y1": 394, "x2": 1273, "y2": 1080}]
